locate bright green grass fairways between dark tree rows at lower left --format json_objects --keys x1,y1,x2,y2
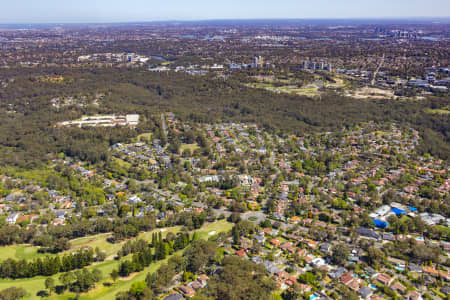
[{"x1": 0, "y1": 220, "x2": 233, "y2": 300}]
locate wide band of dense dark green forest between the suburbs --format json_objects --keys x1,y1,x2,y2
[{"x1": 0, "y1": 68, "x2": 450, "y2": 168}]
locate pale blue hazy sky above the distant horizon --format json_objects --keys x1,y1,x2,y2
[{"x1": 0, "y1": 0, "x2": 450, "y2": 24}]
